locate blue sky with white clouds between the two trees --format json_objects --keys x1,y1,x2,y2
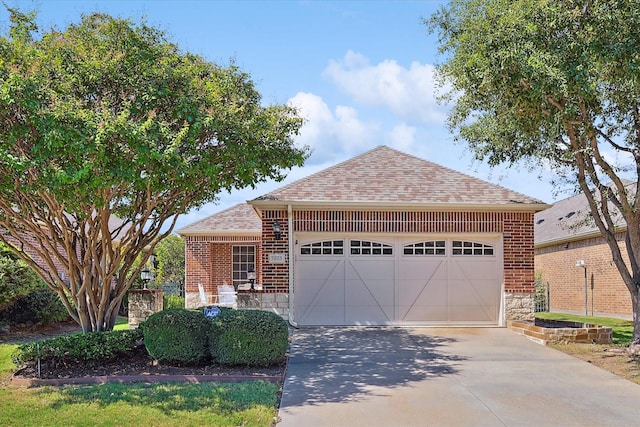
[{"x1": 0, "y1": 0, "x2": 568, "y2": 229}]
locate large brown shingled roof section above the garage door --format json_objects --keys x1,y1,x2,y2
[{"x1": 249, "y1": 146, "x2": 548, "y2": 212}]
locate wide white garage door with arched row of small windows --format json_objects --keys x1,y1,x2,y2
[{"x1": 294, "y1": 235, "x2": 502, "y2": 325}]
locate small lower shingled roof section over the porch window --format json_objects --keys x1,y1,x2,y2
[{"x1": 178, "y1": 203, "x2": 262, "y2": 236}]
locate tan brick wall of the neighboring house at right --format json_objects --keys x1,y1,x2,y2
[{"x1": 535, "y1": 233, "x2": 633, "y2": 317}]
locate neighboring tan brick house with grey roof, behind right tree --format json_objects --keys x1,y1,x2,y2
[{"x1": 535, "y1": 193, "x2": 633, "y2": 318}]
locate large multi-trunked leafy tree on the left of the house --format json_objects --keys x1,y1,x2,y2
[{"x1": 0, "y1": 9, "x2": 307, "y2": 331}]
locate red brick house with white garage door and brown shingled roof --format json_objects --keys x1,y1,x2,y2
[{"x1": 179, "y1": 146, "x2": 548, "y2": 326}]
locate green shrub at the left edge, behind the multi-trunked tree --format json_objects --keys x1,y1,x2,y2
[{"x1": 0, "y1": 242, "x2": 42, "y2": 311}]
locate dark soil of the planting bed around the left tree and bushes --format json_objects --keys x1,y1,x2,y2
[{"x1": 0, "y1": 323, "x2": 285, "y2": 379}]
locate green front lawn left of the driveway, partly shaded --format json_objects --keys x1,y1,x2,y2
[{"x1": 0, "y1": 318, "x2": 279, "y2": 427}]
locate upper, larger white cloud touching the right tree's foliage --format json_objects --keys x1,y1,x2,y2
[{"x1": 324, "y1": 50, "x2": 446, "y2": 124}]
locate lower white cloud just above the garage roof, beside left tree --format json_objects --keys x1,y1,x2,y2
[{"x1": 289, "y1": 92, "x2": 383, "y2": 164}]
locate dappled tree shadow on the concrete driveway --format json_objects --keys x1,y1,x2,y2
[{"x1": 282, "y1": 327, "x2": 464, "y2": 407}]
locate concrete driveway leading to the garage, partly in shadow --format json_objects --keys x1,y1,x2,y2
[{"x1": 277, "y1": 328, "x2": 640, "y2": 427}]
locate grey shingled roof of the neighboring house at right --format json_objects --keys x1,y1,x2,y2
[{"x1": 534, "y1": 189, "x2": 625, "y2": 247}]
